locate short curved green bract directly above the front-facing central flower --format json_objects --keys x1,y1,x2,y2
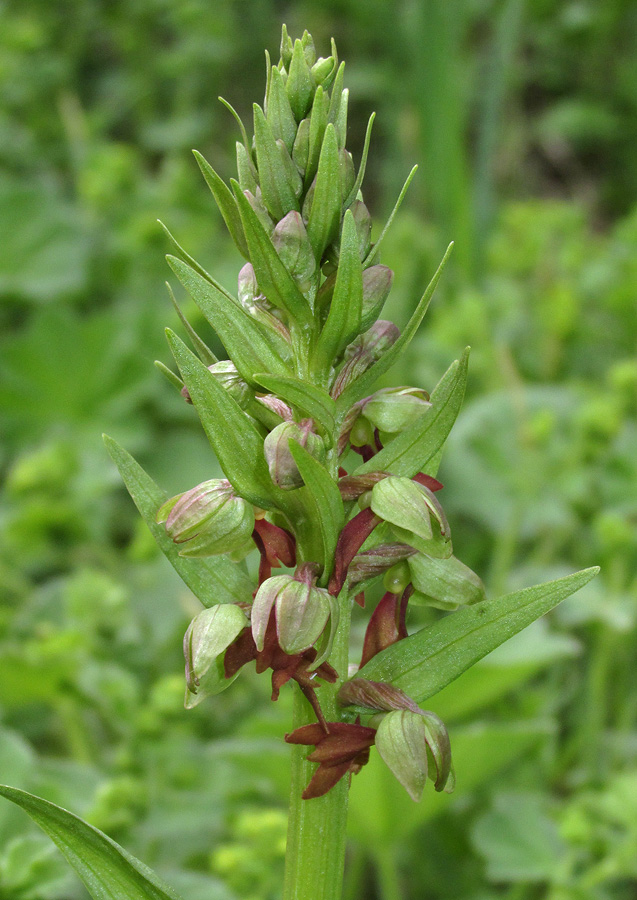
[{"x1": 289, "y1": 441, "x2": 345, "y2": 584}]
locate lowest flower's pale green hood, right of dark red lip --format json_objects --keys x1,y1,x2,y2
[{"x1": 376, "y1": 709, "x2": 451, "y2": 802}]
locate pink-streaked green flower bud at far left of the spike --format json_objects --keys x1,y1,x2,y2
[{"x1": 157, "y1": 479, "x2": 254, "y2": 557}]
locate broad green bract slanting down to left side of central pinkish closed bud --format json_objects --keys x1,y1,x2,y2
[{"x1": 166, "y1": 328, "x2": 273, "y2": 509}]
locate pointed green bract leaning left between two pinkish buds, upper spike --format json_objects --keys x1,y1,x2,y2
[{"x1": 233, "y1": 183, "x2": 311, "y2": 324}]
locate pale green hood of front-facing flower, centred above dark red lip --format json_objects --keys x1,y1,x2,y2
[{"x1": 252, "y1": 575, "x2": 331, "y2": 655}]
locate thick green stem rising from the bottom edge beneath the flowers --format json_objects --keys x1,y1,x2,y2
[{"x1": 283, "y1": 597, "x2": 351, "y2": 900}]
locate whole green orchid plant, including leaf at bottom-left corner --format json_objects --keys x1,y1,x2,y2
[{"x1": 1, "y1": 27, "x2": 596, "y2": 900}]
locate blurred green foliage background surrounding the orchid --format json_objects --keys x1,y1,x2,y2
[{"x1": 0, "y1": 0, "x2": 637, "y2": 900}]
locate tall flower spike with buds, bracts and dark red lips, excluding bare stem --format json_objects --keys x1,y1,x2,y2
[{"x1": 143, "y1": 28, "x2": 483, "y2": 799}]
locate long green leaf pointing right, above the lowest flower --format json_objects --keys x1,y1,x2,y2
[{"x1": 358, "y1": 567, "x2": 599, "y2": 703}]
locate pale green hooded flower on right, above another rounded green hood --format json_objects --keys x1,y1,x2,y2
[{"x1": 371, "y1": 475, "x2": 452, "y2": 557}]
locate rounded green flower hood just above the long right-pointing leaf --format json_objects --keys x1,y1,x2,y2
[{"x1": 409, "y1": 553, "x2": 485, "y2": 609}]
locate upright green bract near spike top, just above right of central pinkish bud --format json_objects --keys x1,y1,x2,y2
[{"x1": 307, "y1": 123, "x2": 341, "y2": 261}]
